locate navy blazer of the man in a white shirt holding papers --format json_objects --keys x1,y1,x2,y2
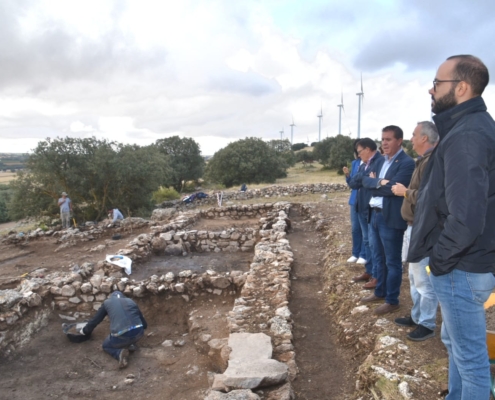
[{"x1": 363, "y1": 151, "x2": 415, "y2": 230}]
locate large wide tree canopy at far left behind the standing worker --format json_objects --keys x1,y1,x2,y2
[{"x1": 9, "y1": 137, "x2": 170, "y2": 219}]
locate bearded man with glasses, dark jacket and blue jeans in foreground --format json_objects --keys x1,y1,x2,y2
[{"x1": 408, "y1": 55, "x2": 495, "y2": 399}]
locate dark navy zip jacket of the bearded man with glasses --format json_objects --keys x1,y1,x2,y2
[{"x1": 407, "y1": 97, "x2": 495, "y2": 275}]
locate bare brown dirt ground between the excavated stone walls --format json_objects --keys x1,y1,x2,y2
[{"x1": 0, "y1": 200, "x2": 454, "y2": 400}]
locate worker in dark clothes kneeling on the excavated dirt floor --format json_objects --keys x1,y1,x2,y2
[{"x1": 81, "y1": 291, "x2": 148, "y2": 368}]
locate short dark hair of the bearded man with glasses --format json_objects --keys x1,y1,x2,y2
[{"x1": 447, "y1": 54, "x2": 490, "y2": 96}]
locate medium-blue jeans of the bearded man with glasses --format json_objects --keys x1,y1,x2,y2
[{"x1": 430, "y1": 269, "x2": 495, "y2": 400}]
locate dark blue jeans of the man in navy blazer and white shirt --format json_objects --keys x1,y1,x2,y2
[{"x1": 369, "y1": 210, "x2": 404, "y2": 305}]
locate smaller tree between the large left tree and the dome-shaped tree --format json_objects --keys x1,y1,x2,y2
[{"x1": 155, "y1": 136, "x2": 205, "y2": 192}]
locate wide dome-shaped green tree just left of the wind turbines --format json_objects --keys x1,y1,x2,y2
[{"x1": 206, "y1": 138, "x2": 287, "y2": 187}]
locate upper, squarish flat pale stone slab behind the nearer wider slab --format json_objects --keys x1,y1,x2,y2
[{"x1": 228, "y1": 333, "x2": 273, "y2": 361}]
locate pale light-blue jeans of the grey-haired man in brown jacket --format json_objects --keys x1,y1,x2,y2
[{"x1": 409, "y1": 257, "x2": 438, "y2": 331}]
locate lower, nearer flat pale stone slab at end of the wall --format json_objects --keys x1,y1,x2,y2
[{"x1": 218, "y1": 359, "x2": 289, "y2": 389}]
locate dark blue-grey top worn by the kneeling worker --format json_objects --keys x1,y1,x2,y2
[{"x1": 84, "y1": 291, "x2": 148, "y2": 336}]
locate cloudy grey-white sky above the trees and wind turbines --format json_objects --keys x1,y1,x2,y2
[{"x1": 0, "y1": 0, "x2": 495, "y2": 155}]
